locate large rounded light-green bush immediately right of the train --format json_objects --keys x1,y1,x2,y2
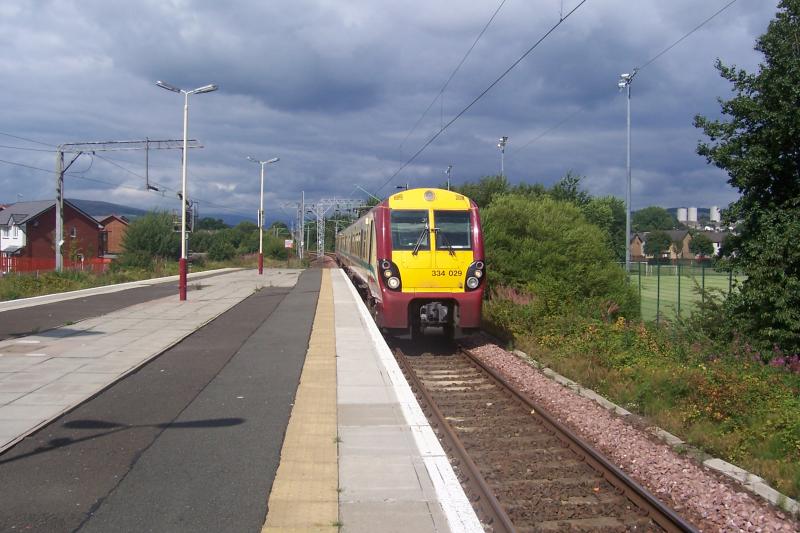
[{"x1": 483, "y1": 195, "x2": 638, "y2": 317}]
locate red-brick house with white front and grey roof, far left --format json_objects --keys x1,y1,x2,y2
[{"x1": 0, "y1": 200, "x2": 105, "y2": 269}]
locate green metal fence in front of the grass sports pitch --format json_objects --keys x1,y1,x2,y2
[{"x1": 623, "y1": 262, "x2": 744, "y2": 323}]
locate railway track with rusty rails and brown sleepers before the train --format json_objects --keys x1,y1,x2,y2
[{"x1": 394, "y1": 345, "x2": 696, "y2": 532}]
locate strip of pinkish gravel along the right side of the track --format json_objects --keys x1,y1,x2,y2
[{"x1": 462, "y1": 341, "x2": 800, "y2": 532}]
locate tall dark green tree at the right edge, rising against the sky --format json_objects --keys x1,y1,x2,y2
[{"x1": 695, "y1": 0, "x2": 800, "y2": 352}]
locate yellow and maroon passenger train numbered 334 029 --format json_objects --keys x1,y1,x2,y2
[{"x1": 335, "y1": 188, "x2": 486, "y2": 338}]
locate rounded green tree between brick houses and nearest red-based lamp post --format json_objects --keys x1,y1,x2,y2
[{"x1": 120, "y1": 211, "x2": 181, "y2": 268}]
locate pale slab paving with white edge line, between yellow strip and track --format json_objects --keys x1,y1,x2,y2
[{"x1": 333, "y1": 271, "x2": 483, "y2": 533}]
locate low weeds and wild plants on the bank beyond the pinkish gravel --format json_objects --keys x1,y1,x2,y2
[{"x1": 484, "y1": 300, "x2": 800, "y2": 498}]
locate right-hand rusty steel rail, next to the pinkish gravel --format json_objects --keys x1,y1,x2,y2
[{"x1": 460, "y1": 347, "x2": 698, "y2": 533}]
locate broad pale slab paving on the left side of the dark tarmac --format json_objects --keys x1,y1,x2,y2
[{"x1": 0, "y1": 269, "x2": 301, "y2": 452}]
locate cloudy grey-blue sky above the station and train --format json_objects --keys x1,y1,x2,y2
[{"x1": 0, "y1": 0, "x2": 777, "y2": 220}]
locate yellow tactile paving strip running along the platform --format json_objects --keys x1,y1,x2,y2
[{"x1": 261, "y1": 270, "x2": 339, "y2": 533}]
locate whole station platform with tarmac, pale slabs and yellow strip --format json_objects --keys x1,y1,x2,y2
[{"x1": 0, "y1": 269, "x2": 483, "y2": 532}]
